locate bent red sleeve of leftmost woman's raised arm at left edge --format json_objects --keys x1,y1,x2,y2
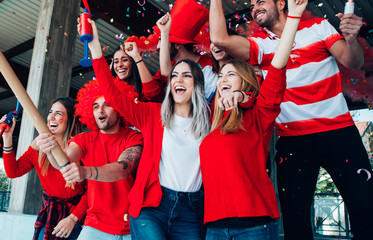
[{"x1": 3, "y1": 146, "x2": 35, "y2": 178}]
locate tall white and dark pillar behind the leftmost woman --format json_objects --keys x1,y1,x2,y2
[{"x1": 9, "y1": 0, "x2": 80, "y2": 214}]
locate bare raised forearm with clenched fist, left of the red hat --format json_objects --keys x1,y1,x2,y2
[{"x1": 157, "y1": 13, "x2": 172, "y2": 77}]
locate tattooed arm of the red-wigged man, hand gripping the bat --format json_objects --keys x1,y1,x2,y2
[{"x1": 61, "y1": 145, "x2": 143, "y2": 183}]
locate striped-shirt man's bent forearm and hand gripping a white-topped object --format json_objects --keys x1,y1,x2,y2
[{"x1": 330, "y1": 13, "x2": 364, "y2": 69}]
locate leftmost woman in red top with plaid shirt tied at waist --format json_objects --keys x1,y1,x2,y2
[{"x1": 2, "y1": 98, "x2": 85, "y2": 240}]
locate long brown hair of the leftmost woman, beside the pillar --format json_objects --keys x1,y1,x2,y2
[{"x1": 38, "y1": 97, "x2": 82, "y2": 176}]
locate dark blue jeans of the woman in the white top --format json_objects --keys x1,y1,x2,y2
[{"x1": 130, "y1": 187, "x2": 205, "y2": 240}]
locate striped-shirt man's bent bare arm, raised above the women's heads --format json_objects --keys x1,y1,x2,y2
[{"x1": 209, "y1": 0, "x2": 250, "y2": 61}]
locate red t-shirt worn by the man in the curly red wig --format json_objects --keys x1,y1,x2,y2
[{"x1": 72, "y1": 127, "x2": 143, "y2": 235}]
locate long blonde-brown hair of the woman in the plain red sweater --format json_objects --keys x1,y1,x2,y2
[{"x1": 211, "y1": 59, "x2": 259, "y2": 134}]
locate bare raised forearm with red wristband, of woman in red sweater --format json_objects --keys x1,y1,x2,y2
[{"x1": 271, "y1": 0, "x2": 308, "y2": 69}]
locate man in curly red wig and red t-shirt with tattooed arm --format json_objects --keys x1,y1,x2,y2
[{"x1": 37, "y1": 81, "x2": 143, "y2": 240}]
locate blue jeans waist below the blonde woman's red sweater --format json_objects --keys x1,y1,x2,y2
[{"x1": 206, "y1": 220, "x2": 279, "y2": 240}]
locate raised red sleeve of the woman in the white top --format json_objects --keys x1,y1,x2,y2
[{"x1": 93, "y1": 55, "x2": 160, "y2": 130}]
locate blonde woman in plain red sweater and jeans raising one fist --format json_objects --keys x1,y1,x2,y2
[{"x1": 200, "y1": 0, "x2": 307, "y2": 240}]
